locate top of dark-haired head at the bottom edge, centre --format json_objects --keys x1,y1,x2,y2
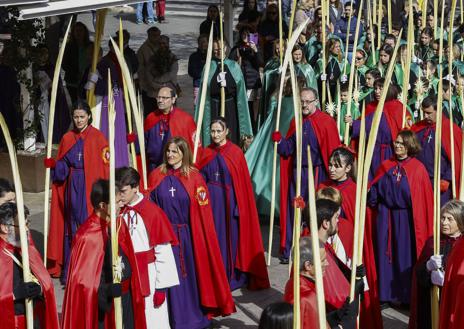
[{"x1": 258, "y1": 302, "x2": 293, "y2": 329}]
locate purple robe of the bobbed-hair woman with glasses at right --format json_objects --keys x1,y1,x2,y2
[{"x1": 369, "y1": 160, "x2": 416, "y2": 304}]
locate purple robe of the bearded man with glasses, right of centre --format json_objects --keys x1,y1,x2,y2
[{"x1": 277, "y1": 120, "x2": 328, "y2": 258}]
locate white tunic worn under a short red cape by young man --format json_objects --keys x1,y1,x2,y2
[{"x1": 124, "y1": 192, "x2": 179, "y2": 329}]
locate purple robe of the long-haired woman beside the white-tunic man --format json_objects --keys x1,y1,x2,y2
[{"x1": 150, "y1": 175, "x2": 210, "y2": 329}]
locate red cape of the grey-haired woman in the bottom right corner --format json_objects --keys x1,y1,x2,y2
[{"x1": 439, "y1": 237, "x2": 464, "y2": 329}]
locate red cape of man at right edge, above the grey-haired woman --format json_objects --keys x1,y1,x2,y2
[{"x1": 411, "y1": 116, "x2": 462, "y2": 196}]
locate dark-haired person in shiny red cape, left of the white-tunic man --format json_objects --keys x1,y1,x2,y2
[{"x1": 62, "y1": 179, "x2": 146, "y2": 329}]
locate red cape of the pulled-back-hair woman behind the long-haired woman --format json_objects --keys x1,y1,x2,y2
[{"x1": 198, "y1": 141, "x2": 270, "y2": 290}]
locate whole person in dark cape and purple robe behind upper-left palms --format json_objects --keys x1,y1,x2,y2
[{"x1": 85, "y1": 41, "x2": 129, "y2": 168}]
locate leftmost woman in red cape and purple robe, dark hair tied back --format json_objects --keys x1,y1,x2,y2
[{"x1": 44, "y1": 101, "x2": 109, "y2": 284}]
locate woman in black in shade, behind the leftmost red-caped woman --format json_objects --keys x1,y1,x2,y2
[{"x1": 62, "y1": 22, "x2": 93, "y2": 102}]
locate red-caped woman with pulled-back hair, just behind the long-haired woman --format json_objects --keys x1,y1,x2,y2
[{"x1": 197, "y1": 117, "x2": 270, "y2": 290}]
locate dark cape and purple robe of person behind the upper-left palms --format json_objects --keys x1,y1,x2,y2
[{"x1": 95, "y1": 55, "x2": 129, "y2": 168}]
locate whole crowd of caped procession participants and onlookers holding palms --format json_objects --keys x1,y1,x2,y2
[{"x1": 0, "y1": 0, "x2": 464, "y2": 329}]
